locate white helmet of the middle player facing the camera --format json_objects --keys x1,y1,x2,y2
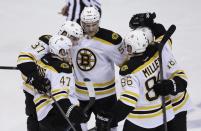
[{"x1": 81, "y1": 7, "x2": 100, "y2": 23}]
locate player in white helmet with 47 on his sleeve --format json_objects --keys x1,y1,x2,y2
[{"x1": 33, "y1": 35, "x2": 85, "y2": 131}]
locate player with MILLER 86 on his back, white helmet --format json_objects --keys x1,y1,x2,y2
[{"x1": 107, "y1": 28, "x2": 187, "y2": 131}]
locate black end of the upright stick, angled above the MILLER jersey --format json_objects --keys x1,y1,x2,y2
[{"x1": 159, "y1": 24, "x2": 176, "y2": 51}]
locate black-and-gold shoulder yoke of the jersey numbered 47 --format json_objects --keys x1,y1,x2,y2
[{"x1": 41, "y1": 53, "x2": 72, "y2": 73}]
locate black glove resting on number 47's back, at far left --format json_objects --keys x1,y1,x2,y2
[{"x1": 26, "y1": 72, "x2": 51, "y2": 94}]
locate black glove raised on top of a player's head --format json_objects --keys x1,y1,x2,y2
[{"x1": 129, "y1": 12, "x2": 156, "y2": 29}]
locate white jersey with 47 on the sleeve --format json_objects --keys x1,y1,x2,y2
[{"x1": 34, "y1": 55, "x2": 79, "y2": 121}]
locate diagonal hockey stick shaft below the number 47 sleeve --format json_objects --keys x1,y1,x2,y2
[{"x1": 47, "y1": 90, "x2": 76, "y2": 131}]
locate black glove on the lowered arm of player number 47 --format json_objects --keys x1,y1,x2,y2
[{"x1": 66, "y1": 105, "x2": 88, "y2": 123}]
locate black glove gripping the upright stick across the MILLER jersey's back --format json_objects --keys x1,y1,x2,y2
[{"x1": 153, "y1": 80, "x2": 177, "y2": 96}]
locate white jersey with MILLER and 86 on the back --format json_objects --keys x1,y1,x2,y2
[{"x1": 120, "y1": 41, "x2": 189, "y2": 128}]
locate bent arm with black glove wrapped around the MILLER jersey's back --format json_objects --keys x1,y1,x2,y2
[{"x1": 153, "y1": 44, "x2": 187, "y2": 96}]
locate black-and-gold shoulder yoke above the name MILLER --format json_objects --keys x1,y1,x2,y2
[{"x1": 119, "y1": 45, "x2": 158, "y2": 76}]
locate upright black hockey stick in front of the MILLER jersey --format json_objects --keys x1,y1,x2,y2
[{"x1": 158, "y1": 25, "x2": 176, "y2": 131}]
